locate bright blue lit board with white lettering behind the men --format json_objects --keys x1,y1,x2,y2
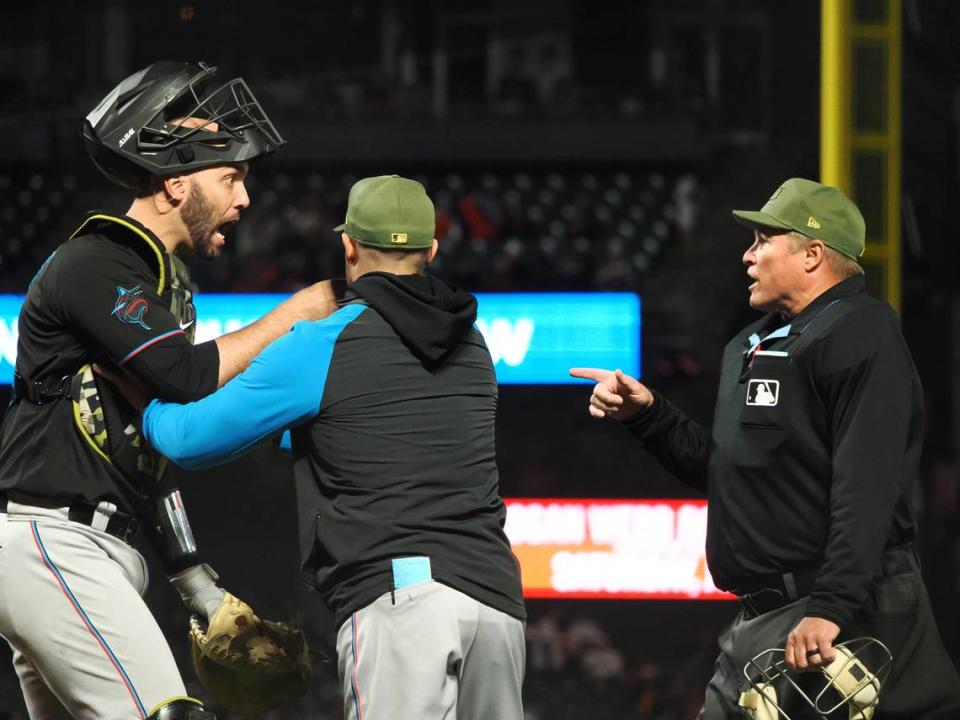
[{"x1": 0, "y1": 293, "x2": 640, "y2": 385}]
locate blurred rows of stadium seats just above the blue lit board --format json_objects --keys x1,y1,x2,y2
[{"x1": 0, "y1": 168, "x2": 698, "y2": 292}]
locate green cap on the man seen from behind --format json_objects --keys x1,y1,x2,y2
[{"x1": 334, "y1": 175, "x2": 437, "y2": 250}]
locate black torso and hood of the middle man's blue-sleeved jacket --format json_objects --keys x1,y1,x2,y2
[{"x1": 293, "y1": 273, "x2": 525, "y2": 626}]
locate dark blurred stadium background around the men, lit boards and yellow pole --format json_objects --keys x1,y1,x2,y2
[{"x1": 0, "y1": 0, "x2": 960, "y2": 720}]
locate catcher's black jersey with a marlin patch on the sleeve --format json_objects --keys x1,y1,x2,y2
[{"x1": 0, "y1": 215, "x2": 220, "y2": 512}]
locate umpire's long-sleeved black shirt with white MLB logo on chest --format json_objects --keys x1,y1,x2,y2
[{"x1": 626, "y1": 276, "x2": 923, "y2": 626}]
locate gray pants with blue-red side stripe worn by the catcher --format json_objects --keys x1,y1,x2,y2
[{"x1": 0, "y1": 502, "x2": 186, "y2": 720}]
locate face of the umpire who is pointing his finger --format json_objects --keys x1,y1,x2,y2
[{"x1": 743, "y1": 229, "x2": 806, "y2": 316}]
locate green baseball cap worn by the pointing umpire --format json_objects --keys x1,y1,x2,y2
[{"x1": 733, "y1": 178, "x2": 866, "y2": 260}]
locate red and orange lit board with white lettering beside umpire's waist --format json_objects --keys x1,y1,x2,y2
[{"x1": 505, "y1": 498, "x2": 733, "y2": 600}]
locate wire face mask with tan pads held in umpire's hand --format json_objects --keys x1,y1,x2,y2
[{"x1": 740, "y1": 637, "x2": 893, "y2": 720}]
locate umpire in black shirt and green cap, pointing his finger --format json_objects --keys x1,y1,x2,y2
[{"x1": 571, "y1": 178, "x2": 960, "y2": 720}]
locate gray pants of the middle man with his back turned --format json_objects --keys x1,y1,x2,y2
[{"x1": 337, "y1": 580, "x2": 526, "y2": 720}]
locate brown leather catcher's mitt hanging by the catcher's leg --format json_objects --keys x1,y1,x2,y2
[{"x1": 190, "y1": 593, "x2": 311, "y2": 716}]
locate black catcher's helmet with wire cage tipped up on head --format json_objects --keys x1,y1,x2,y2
[{"x1": 81, "y1": 61, "x2": 284, "y2": 190}]
